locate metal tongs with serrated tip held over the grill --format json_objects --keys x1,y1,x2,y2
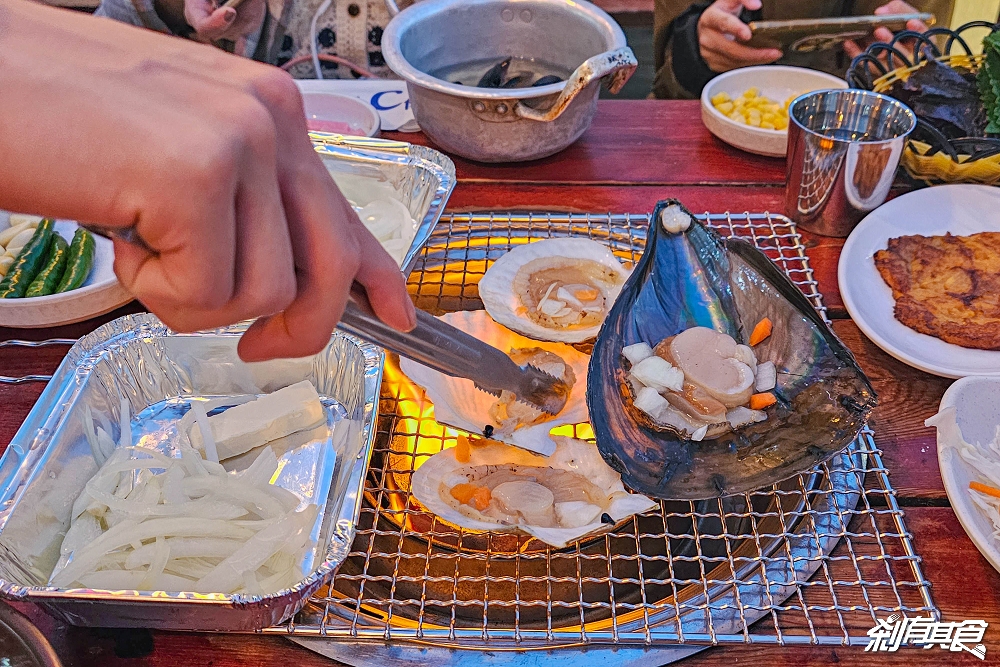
[{"x1": 338, "y1": 283, "x2": 570, "y2": 415}]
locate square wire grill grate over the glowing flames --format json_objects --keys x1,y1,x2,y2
[{"x1": 273, "y1": 213, "x2": 937, "y2": 649}]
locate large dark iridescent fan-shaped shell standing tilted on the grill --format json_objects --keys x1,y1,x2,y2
[{"x1": 587, "y1": 200, "x2": 876, "y2": 500}]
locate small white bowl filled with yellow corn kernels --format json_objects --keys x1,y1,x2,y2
[{"x1": 701, "y1": 65, "x2": 847, "y2": 157}]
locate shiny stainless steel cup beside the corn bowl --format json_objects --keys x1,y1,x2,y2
[{"x1": 785, "y1": 89, "x2": 917, "y2": 237}]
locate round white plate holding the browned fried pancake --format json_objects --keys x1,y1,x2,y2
[{"x1": 837, "y1": 185, "x2": 1000, "y2": 378}]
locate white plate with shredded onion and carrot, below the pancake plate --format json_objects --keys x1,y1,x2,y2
[{"x1": 937, "y1": 377, "x2": 1000, "y2": 571}]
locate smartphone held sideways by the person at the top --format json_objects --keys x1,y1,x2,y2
[{"x1": 746, "y1": 14, "x2": 935, "y2": 53}]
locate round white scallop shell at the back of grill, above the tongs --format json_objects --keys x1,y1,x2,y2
[{"x1": 479, "y1": 238, "x2": 628, "y2": 343}]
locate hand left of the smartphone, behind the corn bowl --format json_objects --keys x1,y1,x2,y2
[{"x1": 698, "y1": 0, "x2": 781, "y2": 72}]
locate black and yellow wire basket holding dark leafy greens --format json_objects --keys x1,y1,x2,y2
[{"x1": 847, "y1": 21, "x2": 1000, "y2": 185}]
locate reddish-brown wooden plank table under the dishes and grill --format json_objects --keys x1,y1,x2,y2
[{"x1": 0, "y1": 101, "x2": 1000, "y2": 667}]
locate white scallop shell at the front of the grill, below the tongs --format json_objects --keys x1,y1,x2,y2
[{"x1": 410, "y1": 436, "x2": 657, "y2": 548}]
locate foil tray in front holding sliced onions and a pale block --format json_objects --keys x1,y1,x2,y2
[{"x1": 0, "y1": 314, "x2": 383, "y2": 632}]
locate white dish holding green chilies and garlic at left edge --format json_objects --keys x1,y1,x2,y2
[{"x1": 0, "y1": 219, "x2": 132, "y2": 328}]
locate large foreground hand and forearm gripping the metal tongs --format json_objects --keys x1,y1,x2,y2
[{"x1": 0, "y1": 0, "x2": 415, "y2": 360}]
